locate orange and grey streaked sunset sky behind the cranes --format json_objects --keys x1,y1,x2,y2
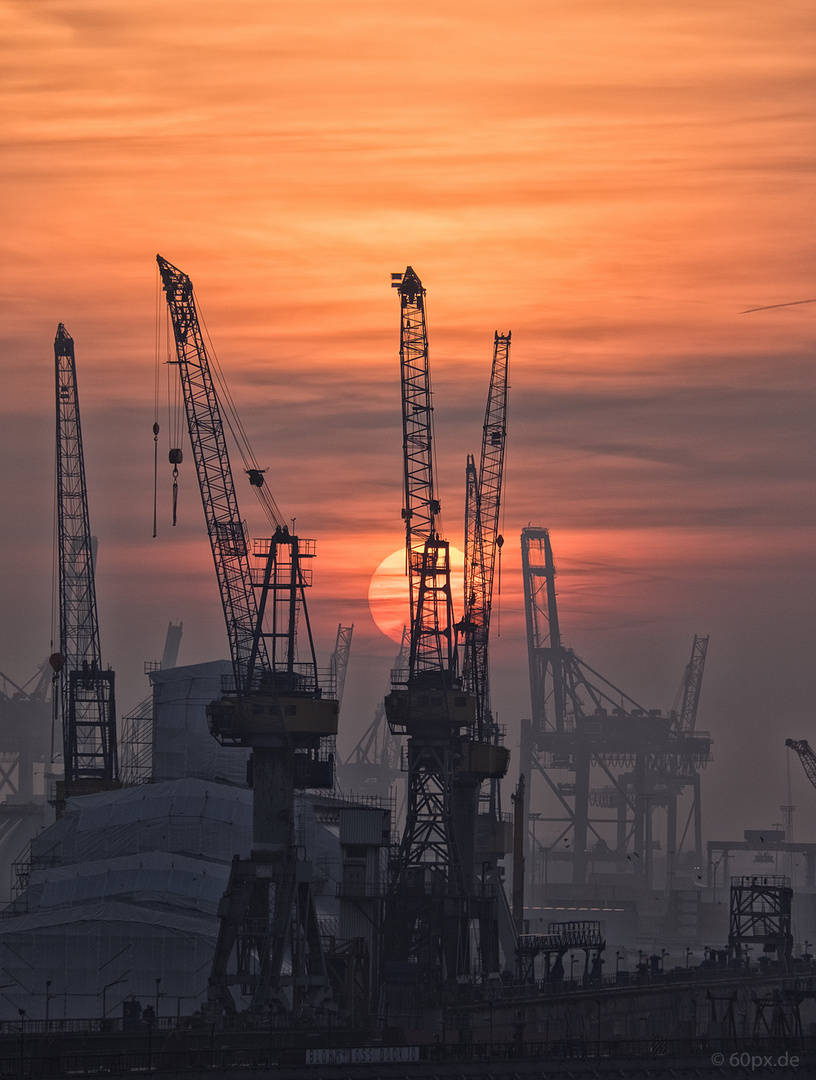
[{"x1": 0, "y1": 0, "x2": 816, "y2": 839}]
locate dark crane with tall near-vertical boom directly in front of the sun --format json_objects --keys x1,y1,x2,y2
[{"x1": 383, "y1": 267, "x2": 506, "y2": 1000}]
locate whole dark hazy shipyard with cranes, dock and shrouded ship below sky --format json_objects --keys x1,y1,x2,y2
[{"x1": 0, "y1": 267, "x2": 816, "y2": 1076}]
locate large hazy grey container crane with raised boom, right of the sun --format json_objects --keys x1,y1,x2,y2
[{"x1": 519, "y1": 526, "x2": 711, "y2": 887}]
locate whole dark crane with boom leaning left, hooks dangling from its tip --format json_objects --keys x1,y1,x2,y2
[{"x1": 157, "y1": 256, "x2": 338, "y2": 1013}]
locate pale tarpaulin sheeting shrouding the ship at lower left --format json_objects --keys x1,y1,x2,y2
[{"x1": 0, "y1": 661, "x2": 339, "y2": 1021}]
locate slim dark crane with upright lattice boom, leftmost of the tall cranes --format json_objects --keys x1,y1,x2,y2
[{"x1": 52, "y1": 323, "x2": 119, "y2": 811}]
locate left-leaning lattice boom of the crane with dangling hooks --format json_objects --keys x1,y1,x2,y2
[{"x1": 157, "y1": 255, "x2": 269, "y2": 690}]
